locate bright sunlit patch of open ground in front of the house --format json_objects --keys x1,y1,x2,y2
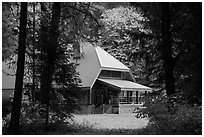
[{"x1": 74, "y1": 114, "x2": 148, "y2": 129}]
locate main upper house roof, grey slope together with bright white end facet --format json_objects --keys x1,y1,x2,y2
[{"x1": 72, "y1": 42, "x2": 130, "y2": 88}]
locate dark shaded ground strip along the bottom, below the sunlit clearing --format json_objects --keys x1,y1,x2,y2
[{"x1": 3, "y1": 122, "x2": 147, "y2": 135}]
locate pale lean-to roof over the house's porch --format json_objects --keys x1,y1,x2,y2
[{"x1": 98, "y1": 78, "x2": 152, "y2": 92}]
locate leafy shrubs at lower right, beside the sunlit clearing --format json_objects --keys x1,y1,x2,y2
[{"x1": 140, "y1": 95, "x2": 202, "y2": 135}]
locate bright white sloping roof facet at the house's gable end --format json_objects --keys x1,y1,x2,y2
[{"x1": 95, "y1": 46, "x2": 129, "y2": 71}]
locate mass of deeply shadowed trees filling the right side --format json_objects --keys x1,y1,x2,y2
[{"x1": 127, "y1": 2, "x2": 202, "y2": 104}]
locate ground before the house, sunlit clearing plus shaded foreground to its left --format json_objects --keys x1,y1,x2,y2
[{"x1": 11, "y1": 114, "x2": 145, "y2": 135}]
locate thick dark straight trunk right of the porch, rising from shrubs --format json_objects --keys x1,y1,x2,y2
[{"x1": 162, "y1": 2, "x2": 176, "y2": 113}]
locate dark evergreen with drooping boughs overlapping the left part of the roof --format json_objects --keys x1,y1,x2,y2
[{"x1": 40, "y1": 3, "x2": 85, "y2": 126}]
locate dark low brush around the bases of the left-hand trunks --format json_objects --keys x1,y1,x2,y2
[{"x1": 2, "y1": 101, "x2": 77, "y2": 134}]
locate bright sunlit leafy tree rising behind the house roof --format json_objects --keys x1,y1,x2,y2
[{"x1": 100, "y1": 4, "x2": 156, "y2": 85}]
